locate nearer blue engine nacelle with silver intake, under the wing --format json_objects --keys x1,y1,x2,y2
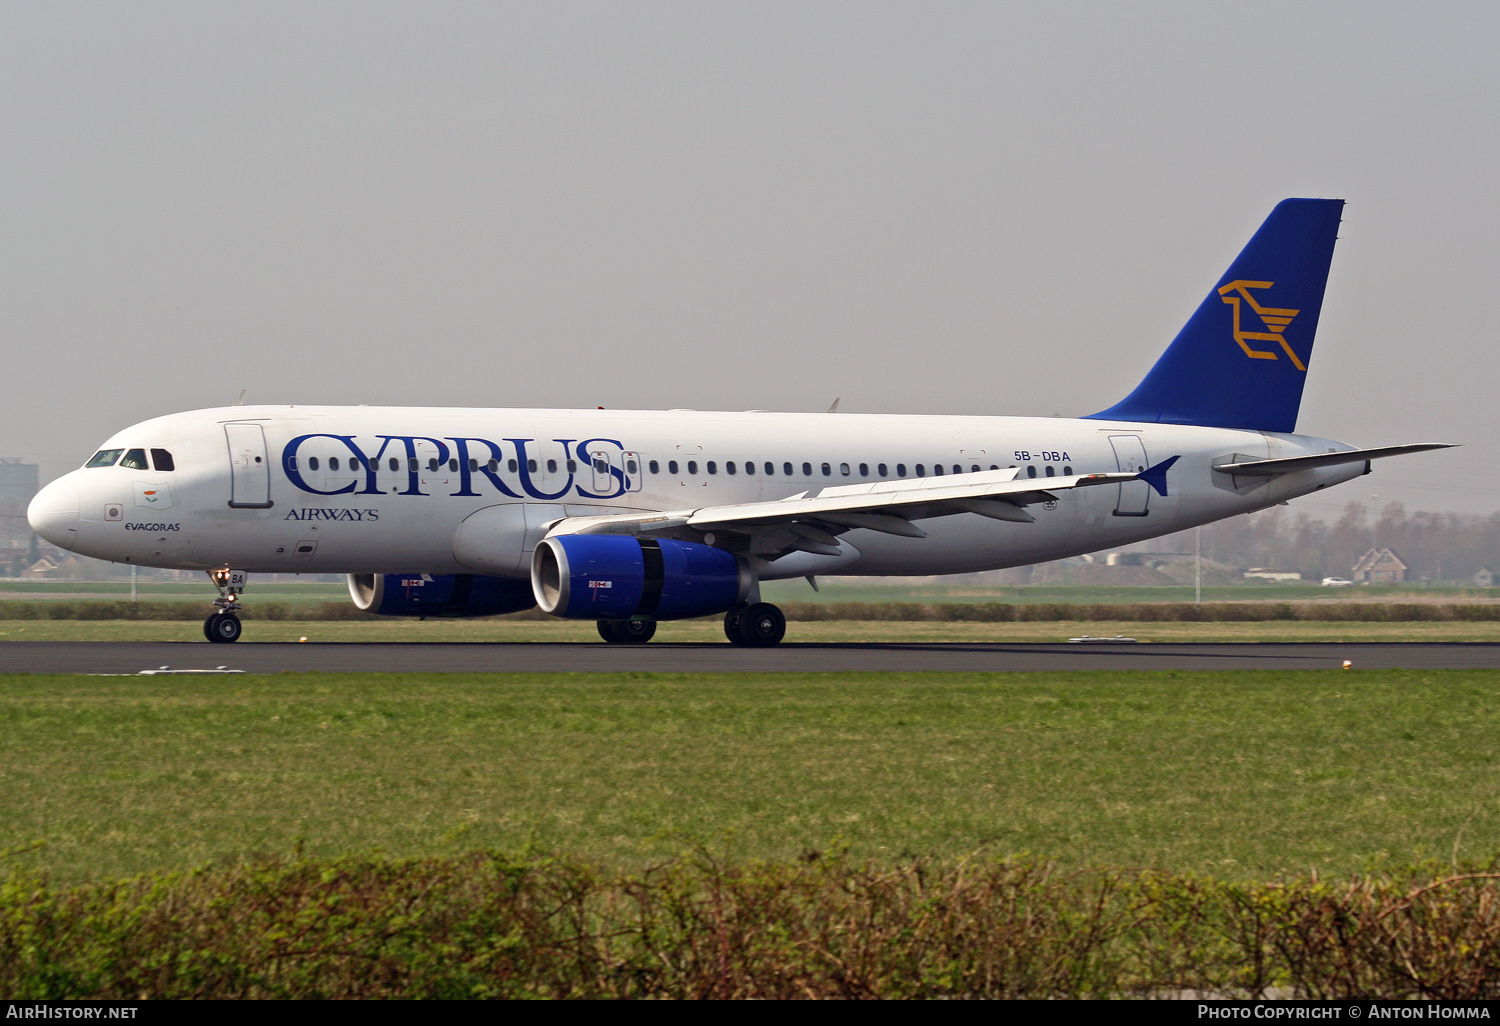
[{"x1": 531, "y1": 534, "x2": 755, "y2": 620}]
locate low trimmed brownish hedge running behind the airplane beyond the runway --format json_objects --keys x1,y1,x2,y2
[{"x1": 0, "y1": 600, "x2": 1500, "y2": 624}]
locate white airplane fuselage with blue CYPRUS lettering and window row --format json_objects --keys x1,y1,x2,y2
[{"x1": 30, "y1": 407, "x2": 1367, "y2": 579}]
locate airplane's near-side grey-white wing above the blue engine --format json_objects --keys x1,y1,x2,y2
[{"x1": 549, "y1": 468, "x2": 1149, "y2": 555}]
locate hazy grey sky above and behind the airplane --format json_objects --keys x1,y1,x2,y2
[{"x1": 0, "y1": 0, "x2": 1500, "y2": 515}]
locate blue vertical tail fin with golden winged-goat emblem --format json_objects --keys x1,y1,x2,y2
[{"x1": 1086, "y1": 200, "x2": 1344, "y2": 432}]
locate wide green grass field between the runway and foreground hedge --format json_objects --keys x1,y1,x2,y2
[{"x1": 0, "y1": 671, "x2": 1500, "y2": 881}]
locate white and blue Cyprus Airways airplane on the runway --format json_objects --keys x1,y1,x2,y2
[{"x1": 27, "y1": 200, "x2": 1448, "y2": 647}]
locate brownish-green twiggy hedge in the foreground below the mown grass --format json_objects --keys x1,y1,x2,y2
[{"x1": 0, "y1": 852, "x2": 1500, "y2": 1001}]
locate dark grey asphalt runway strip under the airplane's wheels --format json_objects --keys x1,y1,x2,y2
[{"x1": 0, "y1": 642, "x2": 1500, "y2": 674}]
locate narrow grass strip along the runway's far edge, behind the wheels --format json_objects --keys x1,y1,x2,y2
[{"x1": 0, "y1": 617, "x2": 1500, "y2": 642}]
